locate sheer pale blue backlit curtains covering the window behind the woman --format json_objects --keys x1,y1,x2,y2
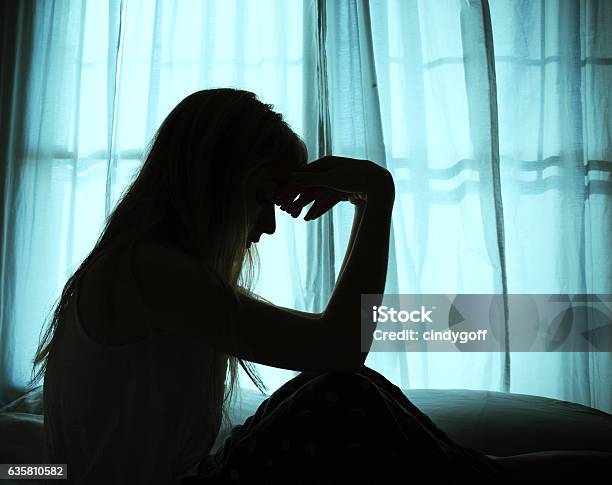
[{"x1": 0, "y1": 0, "x2": 612, "y2": 411}]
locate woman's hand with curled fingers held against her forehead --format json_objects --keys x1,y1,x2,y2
[{"x1": 275, "y1": 156, "x2": 395, "y2": 221}]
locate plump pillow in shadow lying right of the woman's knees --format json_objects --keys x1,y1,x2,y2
[{"x1": 404, "y1": 389, "x2": 612, "y2": 456}]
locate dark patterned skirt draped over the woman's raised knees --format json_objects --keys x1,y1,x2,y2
[{"x1": 183, "y1": 366, "x2": 507, "y2": 485}]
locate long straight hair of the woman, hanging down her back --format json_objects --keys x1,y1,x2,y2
[{"x1": 30, "y1": 88, "x2": 308, "y2": 428}]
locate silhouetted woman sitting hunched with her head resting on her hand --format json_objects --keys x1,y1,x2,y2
[{"x1": 34, "y1": 89, "x2": 505, "y2": 485}]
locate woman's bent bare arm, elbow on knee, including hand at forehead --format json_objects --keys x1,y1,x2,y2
[{"x1": 133, "y1": 159, "x2": 395, "y2": 372}]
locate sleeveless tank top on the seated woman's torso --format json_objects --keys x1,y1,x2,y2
[{"x1": 43, "y1": 240, "x2": 227, "y2": 485}]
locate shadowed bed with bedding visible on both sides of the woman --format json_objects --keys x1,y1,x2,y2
[{"x1": 0, "y1": 387, "x2": 612, "y2": 485}]
